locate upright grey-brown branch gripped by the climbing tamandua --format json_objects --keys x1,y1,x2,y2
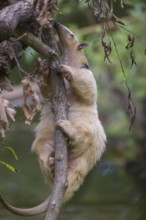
[{"x1": 43, "y1": 28, "x2": 69, "y2": 220}]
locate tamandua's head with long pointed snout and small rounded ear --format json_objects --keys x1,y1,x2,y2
[{"x1": 54, "y1": 22, "x2": 89, "y2": 69}]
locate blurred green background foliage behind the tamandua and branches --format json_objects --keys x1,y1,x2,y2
[{"x1": 0, "y1": 0, "x2": 146, "y2": 220}]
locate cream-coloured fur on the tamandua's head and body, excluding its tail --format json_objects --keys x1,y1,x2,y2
[{"x1": 32, "y1": 25, "x2": 106, "y2": 202}]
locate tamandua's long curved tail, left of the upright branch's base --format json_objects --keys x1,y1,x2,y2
[{"x1": 0, "y1": 195, "x2": 50, "y2": 216}]
